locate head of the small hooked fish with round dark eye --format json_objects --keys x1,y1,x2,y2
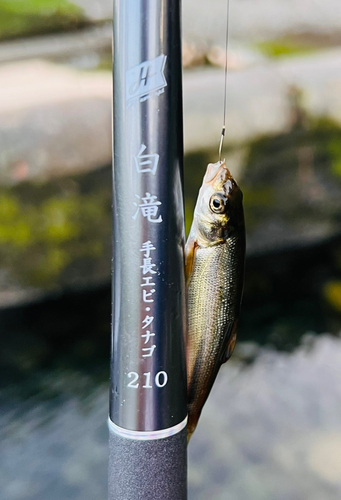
[{"x1": 189, "y1": 161, "x2": 244, "y2": 247}]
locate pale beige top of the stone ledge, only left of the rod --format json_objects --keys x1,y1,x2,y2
[{"x1": 0, "y1": 61, "x2": 112, "y2": 184}]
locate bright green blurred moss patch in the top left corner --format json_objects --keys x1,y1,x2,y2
[{"x1": 0, "y1": 0, "x2": 87, "y2": 39}]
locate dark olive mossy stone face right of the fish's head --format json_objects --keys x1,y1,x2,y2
[{"x1": 240, "y1": 115, "x2": 341, "y2": 233}]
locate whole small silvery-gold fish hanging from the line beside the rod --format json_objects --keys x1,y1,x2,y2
[{"x1": 185, "y1": 161, "x2": 245, "y2": 440}]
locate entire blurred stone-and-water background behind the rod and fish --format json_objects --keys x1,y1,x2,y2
[{"x1": 0, "y1": 0, "x2": 341, "y2": 500}]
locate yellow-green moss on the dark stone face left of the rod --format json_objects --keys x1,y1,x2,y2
[{"x1": 0, "y1": 166, "x2": 111, "y2": 289}]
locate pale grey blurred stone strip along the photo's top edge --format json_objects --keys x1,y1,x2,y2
[{"x1": 74, "y1": 0, "x2": 341, "y2": 46}]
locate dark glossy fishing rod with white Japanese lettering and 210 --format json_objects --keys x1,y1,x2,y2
[{"x1": 109, "y1": 0, "x2": 187, "y2": 500}]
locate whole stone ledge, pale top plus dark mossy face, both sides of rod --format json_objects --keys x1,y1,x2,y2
[{"x1": 0, "y1": 50, "x2": 341, "y2": 307}]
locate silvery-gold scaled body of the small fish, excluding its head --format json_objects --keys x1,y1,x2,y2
[{"x1": 187, "y1": 238, "x2": 240, "y2": 432}]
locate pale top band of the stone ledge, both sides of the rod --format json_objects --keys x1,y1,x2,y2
[{"x1": 0, "y1": 49, "x2": 341, "y2": 183}]
